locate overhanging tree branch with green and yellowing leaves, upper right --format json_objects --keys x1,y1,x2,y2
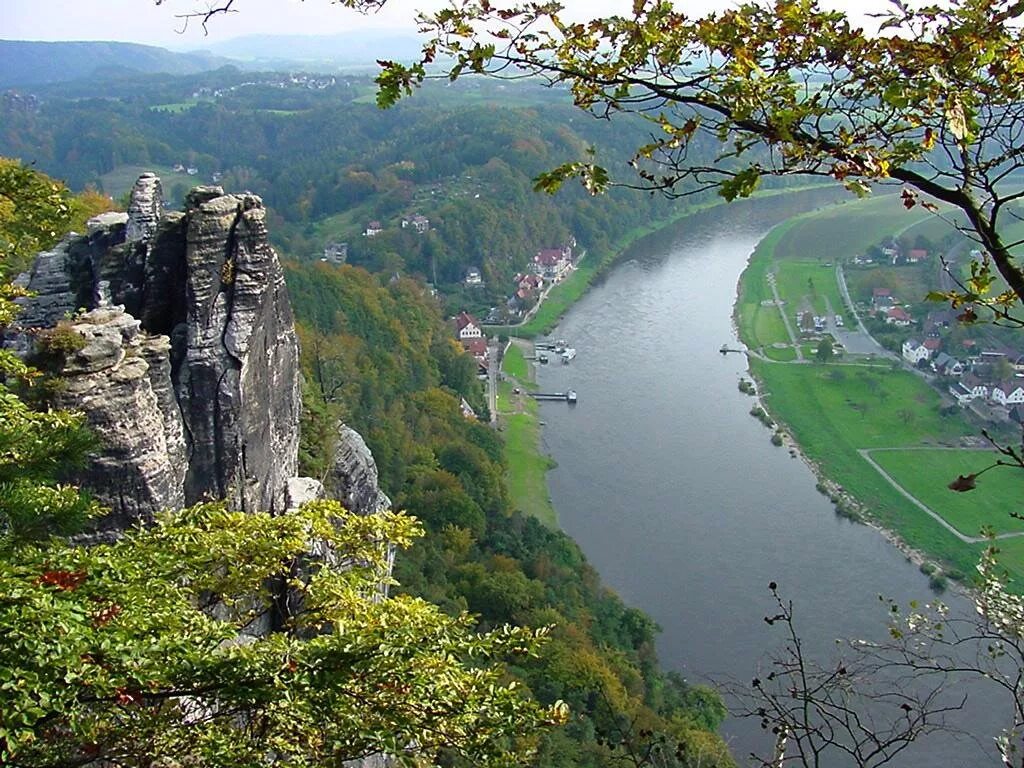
[{"x1": 370, "y1": 0, "x2": 1024, "y2": 317}]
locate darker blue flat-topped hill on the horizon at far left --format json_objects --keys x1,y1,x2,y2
[{"x1": 0, "y1": 40, "x2": 229, "y2": 88}]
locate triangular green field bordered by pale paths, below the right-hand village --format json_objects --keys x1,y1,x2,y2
[{"x1": 871, "y1": 451, "x2": 1024, "y2": 537}]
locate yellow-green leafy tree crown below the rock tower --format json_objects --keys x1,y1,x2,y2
[{"x1": 0, "y1": 502, "x2": 562, "y2": 766}]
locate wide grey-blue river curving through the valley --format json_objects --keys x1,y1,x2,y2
[{"x1": 539, "y1": 200, "x2": 1001, "y2": 768}]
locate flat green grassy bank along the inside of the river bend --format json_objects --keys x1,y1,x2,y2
[{"x1": 734, "y1": 198, "x2": 1024, "y2": 585}]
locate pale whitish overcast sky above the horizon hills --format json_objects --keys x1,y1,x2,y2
[{"x1": 0, "y1": 0, "x2": 881, "y2": 49}]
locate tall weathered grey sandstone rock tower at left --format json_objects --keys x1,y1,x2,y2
[{"x1": 4, "y1": 174, "x2": 311, "y2": 529}]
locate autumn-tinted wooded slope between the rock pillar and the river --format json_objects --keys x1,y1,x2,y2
[{"x1": 288, "y1": 265, "x2": 732, "y2": 766}]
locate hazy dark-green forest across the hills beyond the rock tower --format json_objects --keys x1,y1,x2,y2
[{"x1": 0, "y1": 68, "x2": 745, "y2": 310}]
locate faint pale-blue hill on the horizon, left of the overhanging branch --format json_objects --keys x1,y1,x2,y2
[{"x1": 191, "y1": 30, "x2": 422, "y2": 66}]
